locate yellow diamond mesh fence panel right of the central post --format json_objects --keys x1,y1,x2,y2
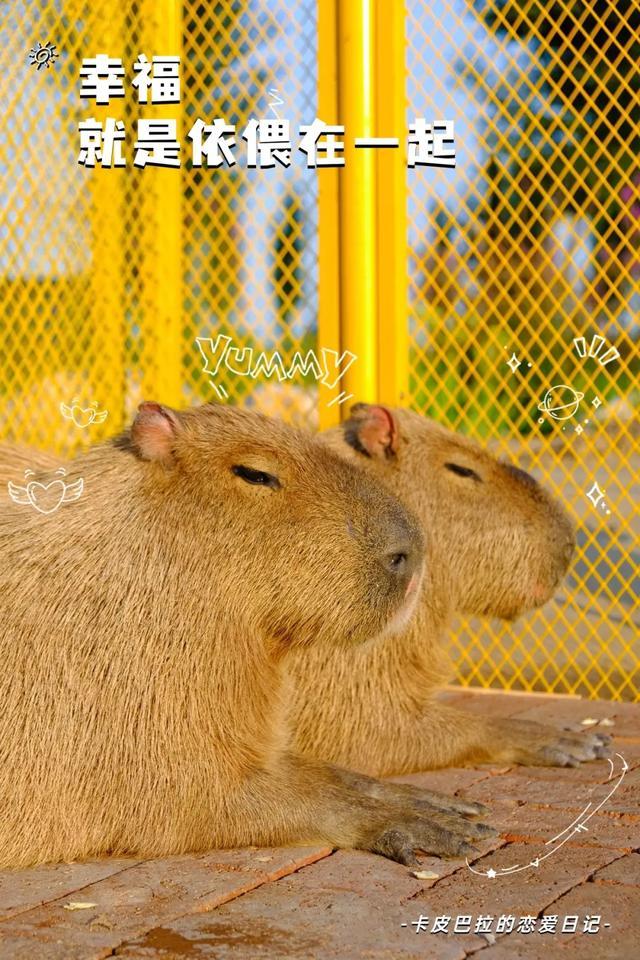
[{"x1": 407, "y1": 0, "x2": 640, "y2": 698}]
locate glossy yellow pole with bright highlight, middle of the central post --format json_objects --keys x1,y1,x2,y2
[{"x1": 337, "y1": 0, "x2": 378, "y2": 401}]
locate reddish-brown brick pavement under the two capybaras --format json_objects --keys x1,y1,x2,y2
[{"x1": 0, "y1": 692, "x2": 640, "y2": 960}]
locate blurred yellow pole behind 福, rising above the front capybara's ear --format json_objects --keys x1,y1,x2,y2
[{"x1": 149, "y1": 0, "x2": 181, "y2": 407}]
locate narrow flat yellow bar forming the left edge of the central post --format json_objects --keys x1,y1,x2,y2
[{"x1": 317, "y1": 0, "x2": 342, "y2": 430}]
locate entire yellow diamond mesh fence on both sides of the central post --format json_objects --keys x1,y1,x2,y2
[{"x1": 0, "y1": 0, "x2": 640, "y2": 698}]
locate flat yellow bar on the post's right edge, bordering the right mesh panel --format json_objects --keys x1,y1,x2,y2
[{"x1": 376, "y1": 0, "x2": 409, "y2": 406}]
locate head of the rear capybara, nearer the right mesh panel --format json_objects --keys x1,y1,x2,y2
[{"x1": 324, "y1": 404, "x2": 574, "y2": 619}]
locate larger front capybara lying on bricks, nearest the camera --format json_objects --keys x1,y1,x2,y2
[{"x1": 0, "y1": 403, "x2": 496, "y2": 867}]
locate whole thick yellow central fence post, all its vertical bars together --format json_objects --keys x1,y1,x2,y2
[{"x1": 318, "y1": 0, "x2": 408, "y2": 426}]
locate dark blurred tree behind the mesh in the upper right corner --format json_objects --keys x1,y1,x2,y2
[{"x1": 458, "y1": 0, "x2": 640, "y2": 312}]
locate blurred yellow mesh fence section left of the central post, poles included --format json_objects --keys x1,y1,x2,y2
[{"x1": 0, "y1": 0, "x2": 318, "y2": 454}]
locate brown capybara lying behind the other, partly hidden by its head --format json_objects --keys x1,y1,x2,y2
[{"x1": 288, "y1": 404, "x2": 609, "y2": 776}]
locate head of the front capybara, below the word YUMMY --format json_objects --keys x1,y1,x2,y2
[{"x1": 120, "y1": 403, "x2": 423, "y2": 644}]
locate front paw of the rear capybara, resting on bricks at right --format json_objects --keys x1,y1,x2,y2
[{"x1": 500, "y1": 720, "x2": 611, "y2": 767}]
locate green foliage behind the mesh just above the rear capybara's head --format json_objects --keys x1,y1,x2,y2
[{"x1": 409, "y1": 309, "x2": 639, "y2": 437}]
